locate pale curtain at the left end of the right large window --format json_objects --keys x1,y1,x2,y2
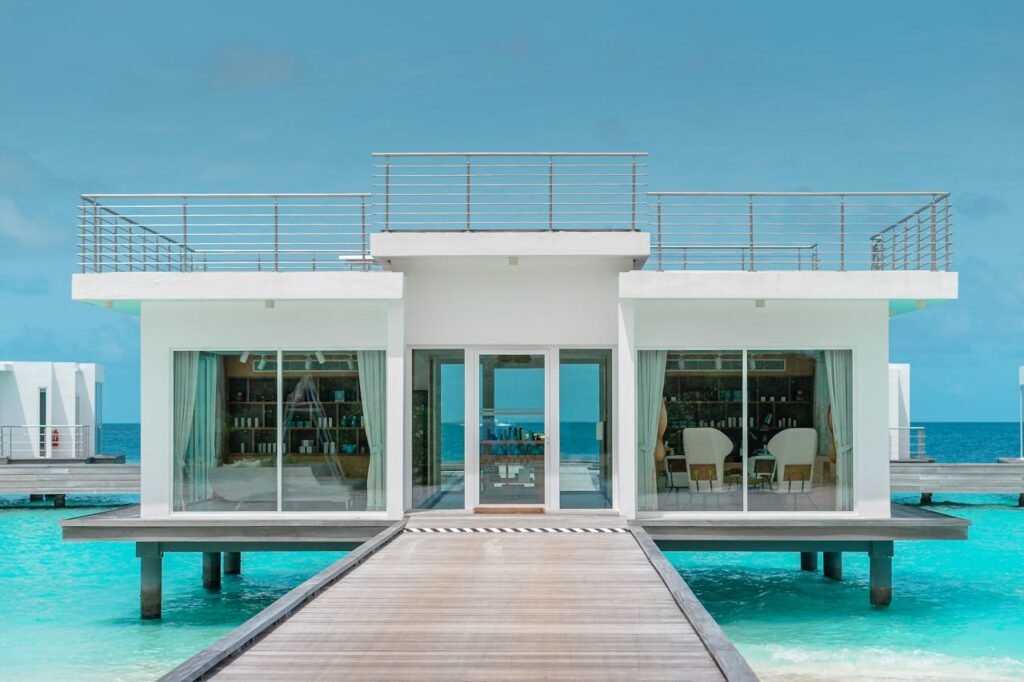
[{"x1": 637, "y1": 350, "x2": 669, "y2": 511}]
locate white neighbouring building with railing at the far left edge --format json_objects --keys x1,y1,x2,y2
[{"x1": 0, "y1": 360, "x2": 103, "y2": 459}]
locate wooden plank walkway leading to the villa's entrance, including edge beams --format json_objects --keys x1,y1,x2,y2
[{"x1": 165, "y1": 513, "x2": 757, "y2": 682}]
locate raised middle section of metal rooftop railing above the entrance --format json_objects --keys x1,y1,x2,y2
[{"x1": 374, "y1": 152, "x2": 647, "y2": 231}]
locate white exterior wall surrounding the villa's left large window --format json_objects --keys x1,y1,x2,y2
[{"x1": 140, "y1": 300, "x2": 404, "y2": 518}]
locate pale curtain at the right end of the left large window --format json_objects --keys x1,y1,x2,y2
[{"x1": 356, "y1": 350, "x2": 387, "y2": 511}]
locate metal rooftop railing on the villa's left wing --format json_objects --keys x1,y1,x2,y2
[{"x1": 79, "y1": 194, "x2": 371, "y2": 272}]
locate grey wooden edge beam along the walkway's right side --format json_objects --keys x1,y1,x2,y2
[{"x1": 629, "y1": 523, "x2": 758, "y2": 682}]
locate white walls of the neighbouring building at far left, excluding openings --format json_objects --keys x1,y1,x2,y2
[{"x1": 0, "y1": 361, "x2": 103, "y2": 458}]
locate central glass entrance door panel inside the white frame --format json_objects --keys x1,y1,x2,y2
[{"x1": 478, "y1": 353, "x2": 547, "y2": 505}]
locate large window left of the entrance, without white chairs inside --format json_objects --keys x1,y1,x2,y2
[{"x1": 172, "y1": 350, "x2": 386, "y2": 511}]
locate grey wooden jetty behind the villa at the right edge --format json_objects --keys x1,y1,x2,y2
[{"x1": 889, "y1": 459, "x2": 1024, "y2": 506}]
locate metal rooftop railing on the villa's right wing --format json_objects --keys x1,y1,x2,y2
[{"x1": 647, "y1": 191, "x2": 952, "y2": 271}]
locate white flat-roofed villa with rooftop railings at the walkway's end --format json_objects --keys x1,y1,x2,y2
[{"x1": 66, "y1": 152, "x2": 966, "y2": 614}]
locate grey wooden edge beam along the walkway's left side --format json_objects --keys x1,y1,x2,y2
[{"x1": 159, "y1": 519, "x2": 406, "y2": 682}]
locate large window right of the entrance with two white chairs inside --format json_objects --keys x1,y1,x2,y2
[{"x1": 637, "y1": 350, "x2": 853, "y2": 511}]
